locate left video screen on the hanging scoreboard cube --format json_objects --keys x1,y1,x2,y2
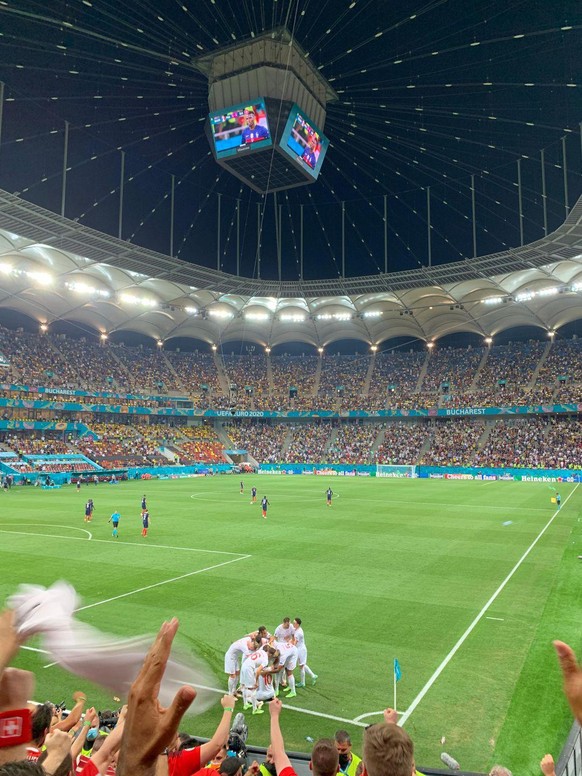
[{"x1": 209, "y1": 98, "x2": 273, "y2": 159}]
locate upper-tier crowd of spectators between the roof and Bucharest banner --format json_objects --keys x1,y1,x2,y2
[{"x1": 0, "y1": 327, "x2": 582, "y2": 411}]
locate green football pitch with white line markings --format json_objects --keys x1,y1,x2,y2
[{"x1": 0, "y1": 475, "x2": 582, "y2": 774}]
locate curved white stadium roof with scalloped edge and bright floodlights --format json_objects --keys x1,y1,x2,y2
[{"x1": 0, "y1": 186, "x2": 582, "y2": 347}]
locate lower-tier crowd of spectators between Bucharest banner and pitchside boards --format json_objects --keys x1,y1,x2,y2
[{"x1": 3, "y1": 414, "x2": 582, "y2": 471}]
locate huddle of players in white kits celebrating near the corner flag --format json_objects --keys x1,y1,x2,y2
[{"x1": 224, "y1": 617, "x2": 317, "y2": 714}]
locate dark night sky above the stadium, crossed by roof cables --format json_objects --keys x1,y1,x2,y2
[{"x1": 0, "y1": 0, "x2": 582, "y2": 279}]
